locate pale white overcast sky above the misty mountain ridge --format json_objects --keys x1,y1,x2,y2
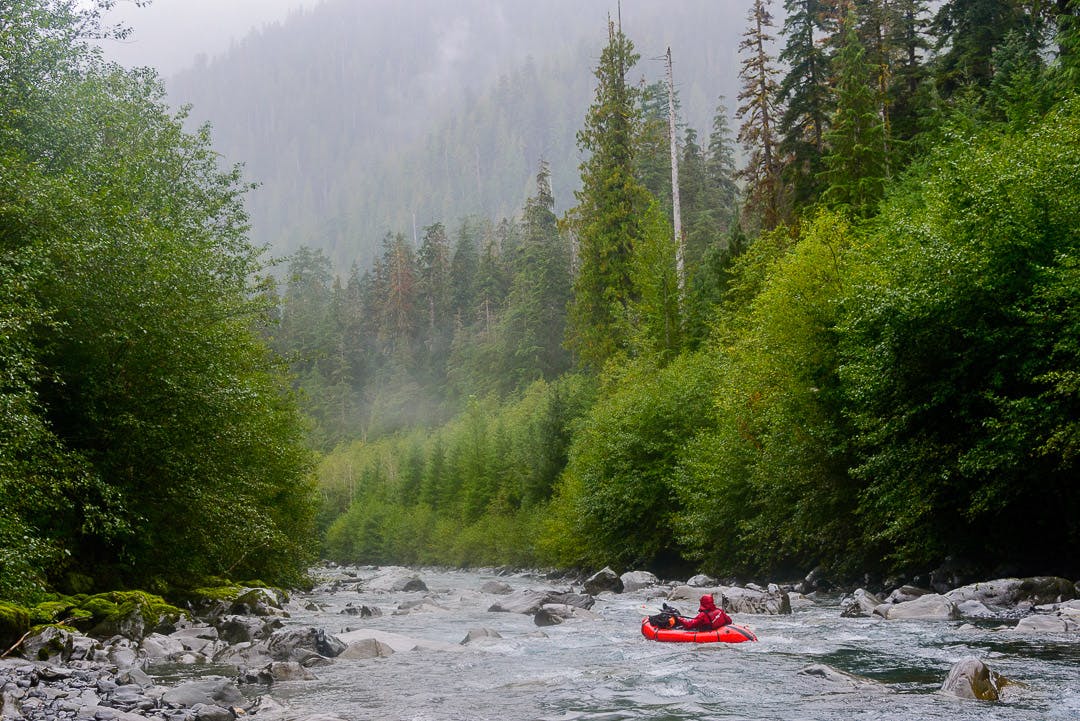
[{"x1": 102, "y1": 0, "x2": 320, "y2": 76}]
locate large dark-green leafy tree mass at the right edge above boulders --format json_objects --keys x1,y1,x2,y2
[{"x1": 841, "y1": 101, "x2": 1080, "y2": 564}]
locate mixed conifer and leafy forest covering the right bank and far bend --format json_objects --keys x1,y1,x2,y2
[{"x1": 304, "y1": 0, "x2": 1080, "y2": 575}]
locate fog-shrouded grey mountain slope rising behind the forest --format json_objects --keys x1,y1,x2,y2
[{"x1": 168, "y1": 0, "x2": 743, "y2": 270}]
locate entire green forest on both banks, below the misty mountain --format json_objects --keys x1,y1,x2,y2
[{"x1": 0, "y1": 0, "x2": 1080, "y2": 613}]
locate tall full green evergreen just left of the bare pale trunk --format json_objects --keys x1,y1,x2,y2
[{"x1": 568, "y1": 21, "x2": 648, "y2": 367}]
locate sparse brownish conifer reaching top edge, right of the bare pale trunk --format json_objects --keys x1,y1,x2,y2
[{"x1": 735, "y1": 0, "x2": 782, "y2": 228}]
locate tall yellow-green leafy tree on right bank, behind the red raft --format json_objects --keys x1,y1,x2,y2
[{"x1": 675, "y1": 209, "x2": 854, "y2": 573}]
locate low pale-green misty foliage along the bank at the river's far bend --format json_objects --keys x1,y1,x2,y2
[{"x1": 319, "y1": 376, "x2": 592, "y2": 566}]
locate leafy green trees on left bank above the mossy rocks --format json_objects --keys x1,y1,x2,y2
[{"x1": 0, "y1": 0, "x2": 318, "y2": 600}]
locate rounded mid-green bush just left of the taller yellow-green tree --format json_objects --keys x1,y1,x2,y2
[{"x1": 541, "y1": 355, "x2": 715, "y2": 568}]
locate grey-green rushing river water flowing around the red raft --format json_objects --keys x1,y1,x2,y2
[{"x1": 159, "y1": 570, "x2": 1080, "y2": 721}]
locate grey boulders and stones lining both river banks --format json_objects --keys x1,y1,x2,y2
[{"x1": 0, "y1": 568, "x2": 1080, "y2": 721}]
